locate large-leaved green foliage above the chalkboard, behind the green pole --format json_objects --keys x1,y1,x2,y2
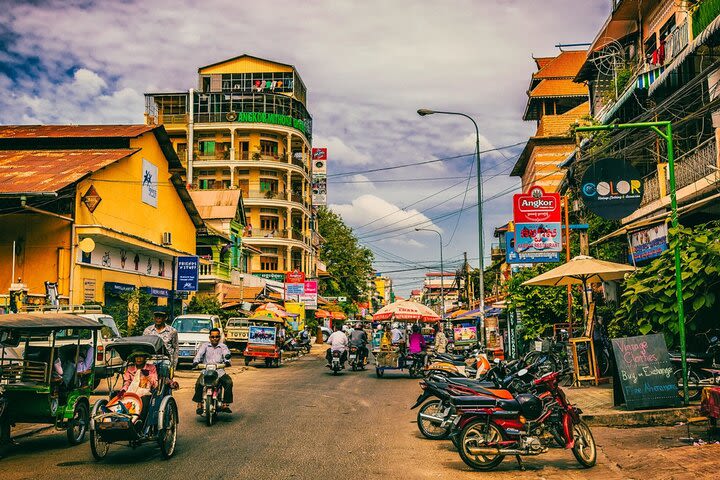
[{"x1": 609, "y1": 222, "x2": 720, "y2": 345}]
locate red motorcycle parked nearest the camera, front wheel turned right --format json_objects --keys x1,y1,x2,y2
[{"x1": 452, "y1": 372, "x2": 597, "y2": 470}]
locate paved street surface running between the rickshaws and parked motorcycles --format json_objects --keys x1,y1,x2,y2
[{"x1": 0, "y1": 348, "x2": 720, "y2": 480}]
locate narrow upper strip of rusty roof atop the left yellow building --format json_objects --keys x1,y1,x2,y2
[{"x1": 0, "y1": 125, "x2": 158, "y2": 138}]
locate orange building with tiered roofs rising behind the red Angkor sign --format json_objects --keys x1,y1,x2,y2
[{"x1": 510, "y1": 51, "x2": 590, "y2": 192}]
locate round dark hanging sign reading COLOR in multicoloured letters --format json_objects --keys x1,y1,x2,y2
[{"x1": 580, "y1": 158, "x2": 643, "y2": 220}]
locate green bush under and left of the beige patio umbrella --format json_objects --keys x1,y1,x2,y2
[{"x1": 507, "y1": 263, "x2": 582, "y2": 340}]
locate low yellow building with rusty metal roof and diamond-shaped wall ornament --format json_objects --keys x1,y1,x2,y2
[{"x1": 0, "y1": 125, "x2": 202, "y2": 305}]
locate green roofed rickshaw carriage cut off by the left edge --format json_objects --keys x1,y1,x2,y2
[{"x1": 0, "y1": 313, "x2": 102, "y2": 450}]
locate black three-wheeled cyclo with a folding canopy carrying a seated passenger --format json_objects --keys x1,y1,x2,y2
[{"x1": 90, "y1": 335, "x2": 178, "y2": 460}]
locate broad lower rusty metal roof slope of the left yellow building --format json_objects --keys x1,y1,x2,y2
[{"x1": 0, "y1": 149, "x2": 138, "y2": 193}]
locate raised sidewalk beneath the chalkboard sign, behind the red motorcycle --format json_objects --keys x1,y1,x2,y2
[{"x1": 564, "y1": 383, "x2": 700, "y2": 427}]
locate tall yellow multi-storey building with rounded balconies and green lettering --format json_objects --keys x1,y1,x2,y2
[{"x1": 145, "y1": 55, "x2": 317, "y2": 281}]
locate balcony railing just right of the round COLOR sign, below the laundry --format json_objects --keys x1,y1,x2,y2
[{"x1": 640, "y1": 137, "x2": 717, "y2": 206}]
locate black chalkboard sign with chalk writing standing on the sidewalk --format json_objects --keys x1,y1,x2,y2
[{"x1": 612, "y1": 334, "x2": 680, "y2": 410}]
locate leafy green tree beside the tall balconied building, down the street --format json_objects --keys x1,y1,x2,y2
[{"x1": 317, "y1": 207, "x2": 373, "y2": 303}]
